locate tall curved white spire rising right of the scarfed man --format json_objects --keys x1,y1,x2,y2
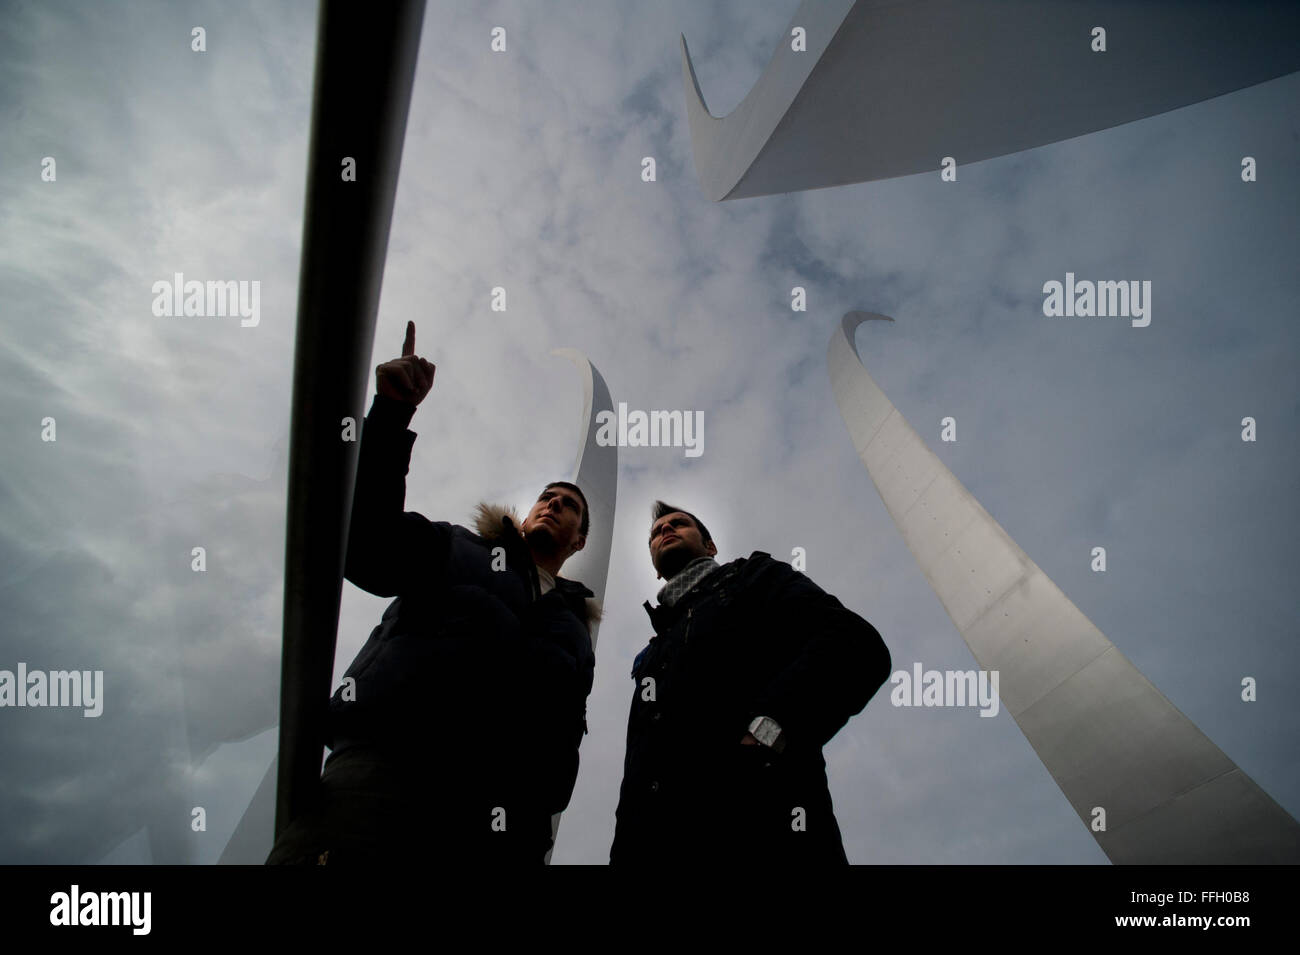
[{"x1": 827, "y1": 312, "x2": 1300, "y2": 864}]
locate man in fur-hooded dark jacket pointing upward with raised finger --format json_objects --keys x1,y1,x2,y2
[{"x1": 267, "y1": 322, "x2": 599, "y2": 868}]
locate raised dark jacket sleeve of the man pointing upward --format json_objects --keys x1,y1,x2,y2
[{"x1": 343, "y1": 394, "x2": 451, "y2": 596}]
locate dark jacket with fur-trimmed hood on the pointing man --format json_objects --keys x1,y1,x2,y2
[{"x1": 329, "y1": 395, "x2": 598, "y2": 861}]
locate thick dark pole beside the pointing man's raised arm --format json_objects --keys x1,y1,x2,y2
[{"x1": 276, "y1": 0, "x2": 424, "y2": 835}]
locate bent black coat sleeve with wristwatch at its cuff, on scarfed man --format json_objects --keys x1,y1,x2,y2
[{"x1": 748, "y1": 560, "x2": 892, "y2": 750}]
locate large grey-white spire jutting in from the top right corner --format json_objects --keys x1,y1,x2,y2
[{"x1": 681, "y1": 0, "x2": 1300, "y2": 201}]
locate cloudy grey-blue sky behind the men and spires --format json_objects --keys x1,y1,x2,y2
[{"x1": 0, "y1": 0, "x2": 1300, "y2": 864}]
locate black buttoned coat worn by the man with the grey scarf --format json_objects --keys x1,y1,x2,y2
[{"x1": 610, "y1": 551, "x2": 891, "y2": 865}]
